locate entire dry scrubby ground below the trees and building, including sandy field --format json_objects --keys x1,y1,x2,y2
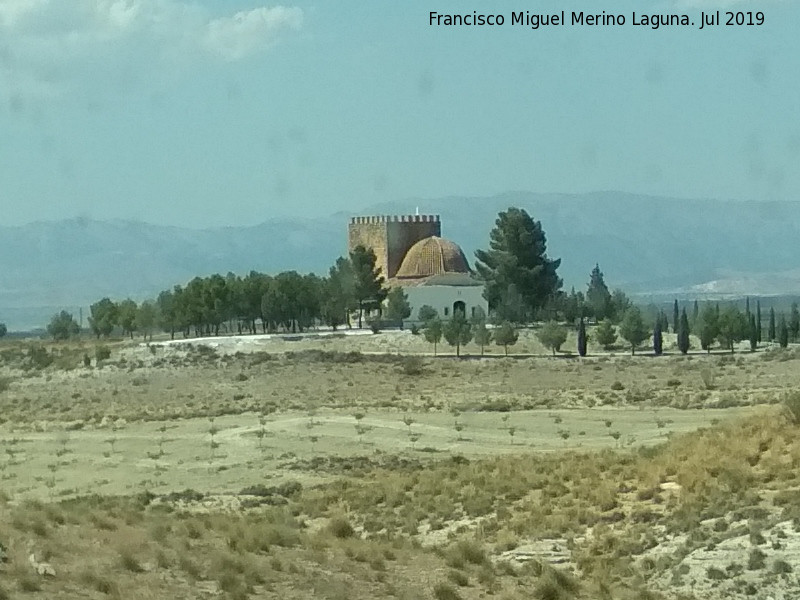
[{"x1": 0, "y1": 333, "x2": 800, "y2": 600}]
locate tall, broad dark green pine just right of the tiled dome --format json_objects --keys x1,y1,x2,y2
[{"x1": 475, "y1": 207, "x2": 562, "y2": 314}]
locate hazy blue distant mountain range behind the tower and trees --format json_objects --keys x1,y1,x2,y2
[{"x1": 0, "y1": 192, "x2": 800, "y2": 329}]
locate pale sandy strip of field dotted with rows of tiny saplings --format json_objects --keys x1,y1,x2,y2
[{"x1": 0, "y1": 408, "x2": 753, "y2": 500}]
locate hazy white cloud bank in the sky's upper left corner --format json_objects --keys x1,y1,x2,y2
[{"x1": 0, "y1": 0, "x2": 303, "y2": 95}]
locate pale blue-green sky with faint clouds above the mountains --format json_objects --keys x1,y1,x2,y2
[{"x1": 0, "y1": 0, "x2": 800, "y2": 227}]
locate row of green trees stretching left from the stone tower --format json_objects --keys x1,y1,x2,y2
[{"x1": 47, "y1": 246, "x2": 400, "y2": 339}]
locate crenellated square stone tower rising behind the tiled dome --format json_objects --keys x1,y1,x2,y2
[{"x1": 347, "y1": 215, "x2": 442, "y2": 279}]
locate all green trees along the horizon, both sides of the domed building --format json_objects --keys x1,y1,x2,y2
[{"x1": 42, "y1": 207, "x2": 800, "y2": 354}]
